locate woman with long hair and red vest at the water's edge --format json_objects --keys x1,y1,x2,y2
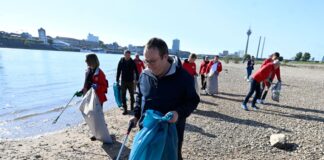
[{"x1": 75, "y1": 54, "x2": 109, "y2": 141}]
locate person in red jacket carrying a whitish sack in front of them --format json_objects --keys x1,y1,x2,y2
[{"x1": 206, "y1": 55, "x2": 222, "y2": 95}]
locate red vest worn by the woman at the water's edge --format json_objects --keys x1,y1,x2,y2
[{"x1": 83, "y1": 68, "x2": 109, "y2": 104}]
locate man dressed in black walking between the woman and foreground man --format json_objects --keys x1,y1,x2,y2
[{"x1": 116, "y1": 50, "x2": 138, "y2": 115}]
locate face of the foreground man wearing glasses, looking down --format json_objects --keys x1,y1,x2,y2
[{"x1": 144, "y1": 48, "x2": 168, "y2": 76}]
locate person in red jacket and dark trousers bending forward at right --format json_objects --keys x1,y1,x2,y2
[{"x1": 241, "y1": 60, "x2": 280, "y2": 111}]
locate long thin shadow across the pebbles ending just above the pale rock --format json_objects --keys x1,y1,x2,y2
[{"x1": 193, "y1": 109, "x2": 291, "y2": 132}]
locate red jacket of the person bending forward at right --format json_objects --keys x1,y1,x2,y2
[{"x1": 252, "y1": 63, "x2": 275, "y2": 83}]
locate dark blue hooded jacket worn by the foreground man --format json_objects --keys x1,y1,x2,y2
[{"x1": 134, "y1": 57, "x2": 200, "y2": 122}]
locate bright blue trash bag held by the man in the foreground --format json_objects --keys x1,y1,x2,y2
[{"x1": 129, "y1": 110, "x2": 178, "y2": 160}]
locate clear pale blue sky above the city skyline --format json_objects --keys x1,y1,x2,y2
[{"x1": 0, "y1": 0, "x2": 324, "y2": 60}]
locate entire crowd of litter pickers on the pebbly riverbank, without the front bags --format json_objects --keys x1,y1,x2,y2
[{"x1": 76, "y1": 38, "x2": 281, "y2": 159}]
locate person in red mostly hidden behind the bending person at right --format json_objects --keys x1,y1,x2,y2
[{"x1": 257, "y1": 52, "x2": 281, "y2": 104}]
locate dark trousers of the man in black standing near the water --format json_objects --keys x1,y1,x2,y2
[{"x1": 121, "y1": 82, "x2": 135, "y2": 111}]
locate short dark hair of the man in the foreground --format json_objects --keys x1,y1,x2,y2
[{"x1": 145, "y1": 37, "x2": 169, "y2": 58}]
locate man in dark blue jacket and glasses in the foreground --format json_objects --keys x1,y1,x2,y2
[{"x1": 131, "y1": 38, "x2": 200, "y2": 159}]
